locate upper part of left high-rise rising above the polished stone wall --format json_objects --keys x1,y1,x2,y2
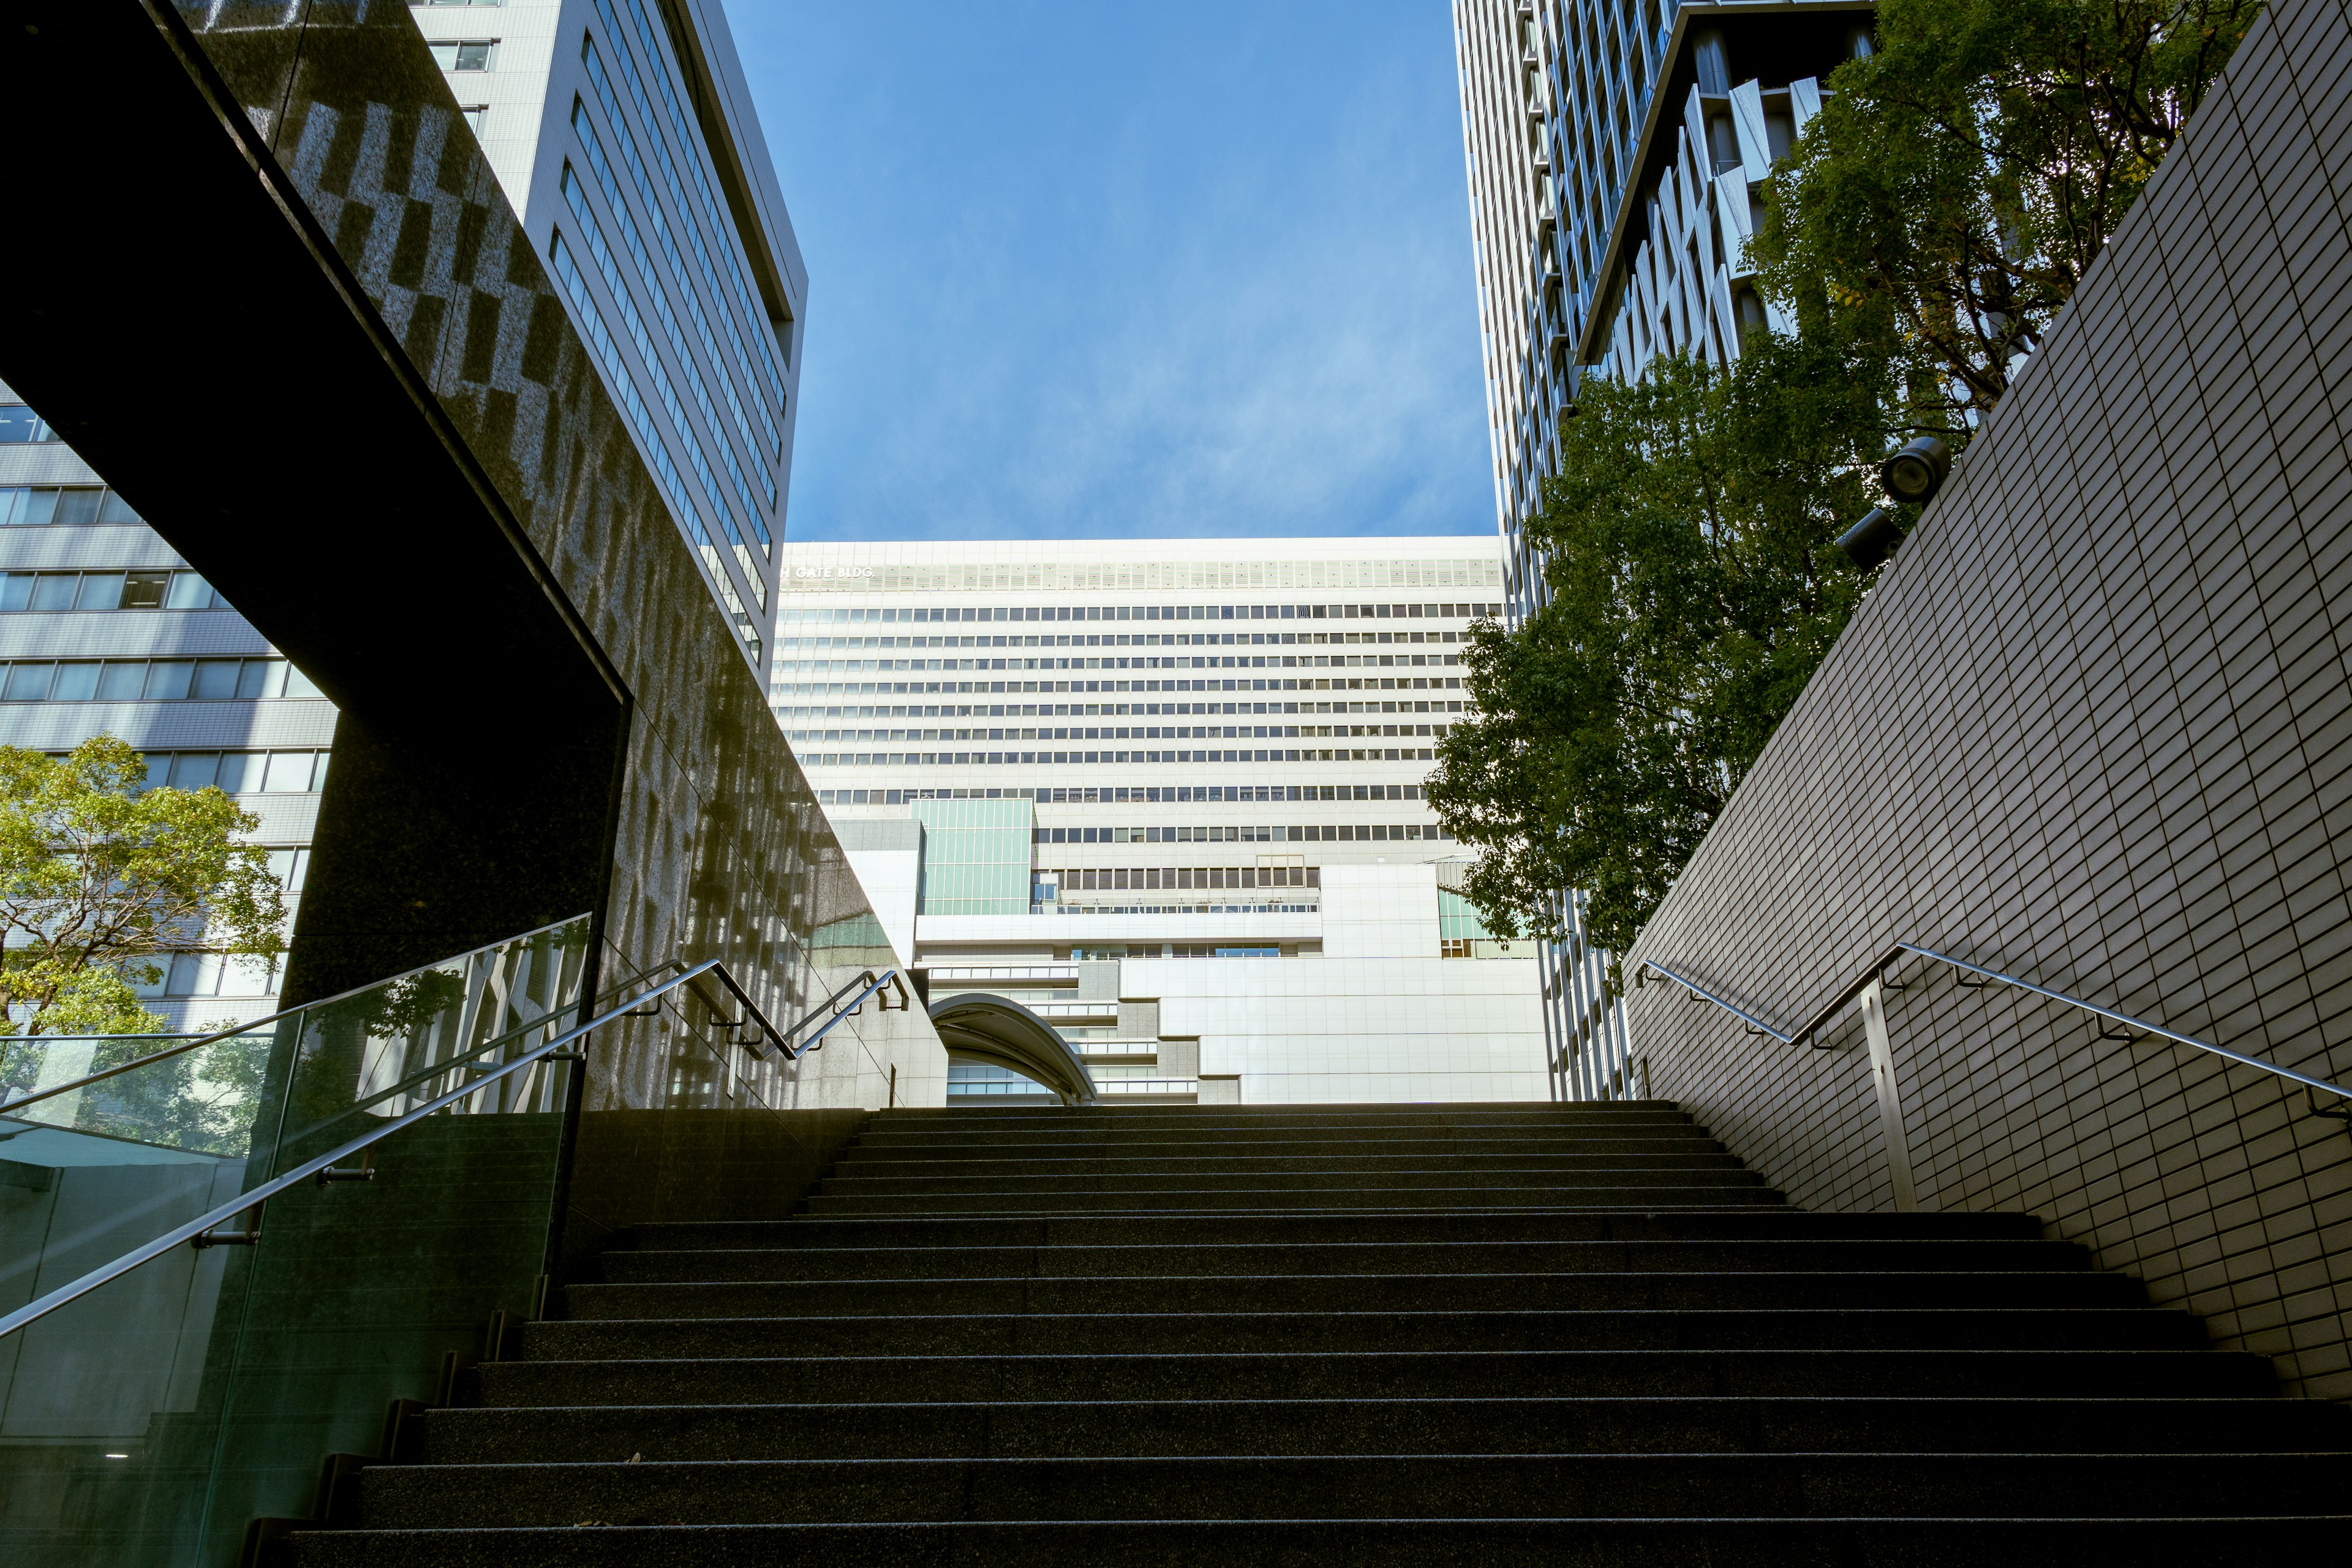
[{"x1": 409, "y1": 0, "x2": 809, "y2": 670}]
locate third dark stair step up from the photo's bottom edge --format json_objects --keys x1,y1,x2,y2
[{"x1": 417, "y1": 1396, "x2": 2352, "y2": 1464}]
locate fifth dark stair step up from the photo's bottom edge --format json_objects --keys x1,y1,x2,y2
[{"x1": 524, "y1": 1284, "x2": 2206, "y2": 1361}]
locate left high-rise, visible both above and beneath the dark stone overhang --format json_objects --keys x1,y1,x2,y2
[{"x1": 0, "y1": 0, "x2": 807, "y2": 1030}]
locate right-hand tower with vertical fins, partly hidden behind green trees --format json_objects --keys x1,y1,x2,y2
[{"x1": 1453, "y1": 0, "x2": 1874, "y2": 1098}]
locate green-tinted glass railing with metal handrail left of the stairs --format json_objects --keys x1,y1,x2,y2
[{"x1": 0, "y1": 919, "x2": 588, "y2": 1568}]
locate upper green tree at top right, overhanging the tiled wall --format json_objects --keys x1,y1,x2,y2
[{"x1": 1752, "y1": 0, "x2": 2260, "y2": 432}]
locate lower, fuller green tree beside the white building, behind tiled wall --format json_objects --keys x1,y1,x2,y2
[{"x1": 1428, "y1": 334, "x2": 1887, "y2": 952}]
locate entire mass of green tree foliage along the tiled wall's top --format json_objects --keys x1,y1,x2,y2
[{"x1": 1430, "y1": 0, "x2": 2260, "y2": 952}]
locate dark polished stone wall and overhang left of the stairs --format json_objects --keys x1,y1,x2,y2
[{"x1": 0, "y1": 0, "x2": 946, "y2": 1107}]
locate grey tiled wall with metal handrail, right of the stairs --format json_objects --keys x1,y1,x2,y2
[{"x1": 1627, "y1": 0, "x2": 2352, "y2": 1399}]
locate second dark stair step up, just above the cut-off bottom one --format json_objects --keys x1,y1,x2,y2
[{"x1": 343, "y1": 1450, "x2": 2352, "y2": 1531}]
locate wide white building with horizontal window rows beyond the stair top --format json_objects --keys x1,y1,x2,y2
[{"x1": 772, "y1": 538, "x2": 1548, "y2": 1102}]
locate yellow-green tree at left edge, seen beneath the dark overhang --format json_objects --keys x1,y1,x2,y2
[{"x1": 0, "y1": 736, "x2": 285, "y2": 1035}]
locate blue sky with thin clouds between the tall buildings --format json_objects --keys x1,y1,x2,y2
[{"x1": 729, "y1": 0, "x2": 1493, "y2": 541}]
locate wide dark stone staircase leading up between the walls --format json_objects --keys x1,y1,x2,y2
[{"x1": 273, "y1": 1102, "x2": 2352, "y2": 1568}]
